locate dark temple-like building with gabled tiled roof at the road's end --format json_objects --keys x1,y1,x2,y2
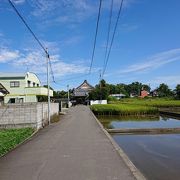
[{"x1": 72, "y1": 80, "x2": 94, "y2": 104}]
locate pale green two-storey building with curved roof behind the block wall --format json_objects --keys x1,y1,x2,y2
[{"x1": 0, "y1": 72, "x2": 53, "y2": 103}]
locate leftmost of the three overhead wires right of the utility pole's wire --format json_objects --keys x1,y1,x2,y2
[{"x1": 89, "y1": 0, "x2": 102, "y2": 74}]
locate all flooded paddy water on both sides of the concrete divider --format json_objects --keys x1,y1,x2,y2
[{"x1": 98, "y1": 116, "x2": 180, "y2": 180}]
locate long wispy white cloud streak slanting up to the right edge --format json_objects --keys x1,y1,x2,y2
[{"x1": 120, "y1": 48, "x2": 180, "y2": 74}]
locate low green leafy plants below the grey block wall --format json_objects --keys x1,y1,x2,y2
[{"x1": 0, "y1": 128, "x2": 34, "y2": 156}]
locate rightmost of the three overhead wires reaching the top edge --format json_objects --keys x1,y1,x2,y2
[{"x1": 102, "y1": 0, "x2": 123, "y2": 77}]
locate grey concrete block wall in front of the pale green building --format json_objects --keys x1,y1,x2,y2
[{"x1": 0, "y1": 103, "x2": 59, "y2": 129}]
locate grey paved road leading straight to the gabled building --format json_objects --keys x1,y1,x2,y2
[{"x1": 0, "y1": 106, "x2": 134, "y2": 180}]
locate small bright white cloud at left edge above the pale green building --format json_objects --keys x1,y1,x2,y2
[{"x1": 0, "y1": 48, "x2": 20, "y2": 63}]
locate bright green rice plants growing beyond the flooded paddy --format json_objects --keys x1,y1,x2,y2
[{"x1": 91, "y1": 98, "x2": 180, "y2": 115}]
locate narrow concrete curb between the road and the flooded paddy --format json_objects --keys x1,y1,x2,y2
[{"x1": 89, "y1": 108, "x2": 146, "y2": 180}]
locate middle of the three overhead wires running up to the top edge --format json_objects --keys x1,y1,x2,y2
[{"x1": 103, "y1": 0, "x2": 114, "y2": 70}]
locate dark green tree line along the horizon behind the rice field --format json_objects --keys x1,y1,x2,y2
[{"x1": 54, "y1": 79, "x2": 180, "y2": 100}]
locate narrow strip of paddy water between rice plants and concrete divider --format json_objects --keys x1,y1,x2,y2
[{"x1": 98, "y1": 116, "x2": 180, "y2": 129}]
